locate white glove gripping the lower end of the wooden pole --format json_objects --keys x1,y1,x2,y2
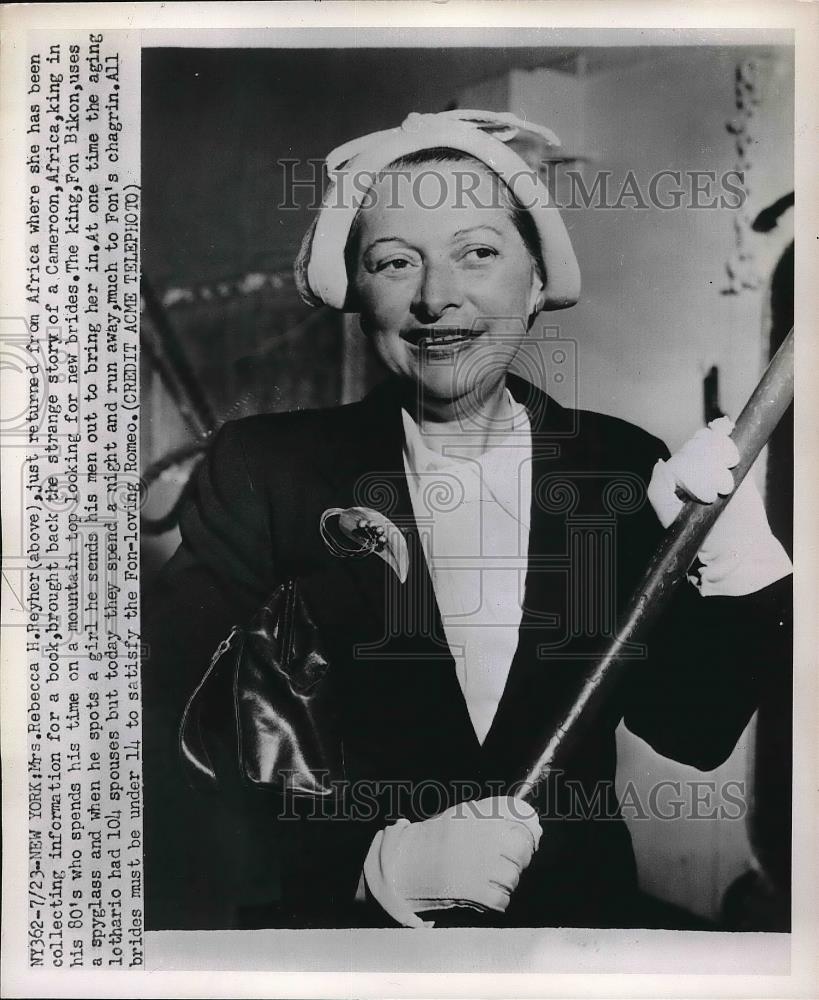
[{"x1": 364, "y1": 797, "x2": 542, "y2": 927}]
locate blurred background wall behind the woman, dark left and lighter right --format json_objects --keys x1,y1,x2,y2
[{"x1": 142, "y1": 46, "x2": 793, "y2": 919}]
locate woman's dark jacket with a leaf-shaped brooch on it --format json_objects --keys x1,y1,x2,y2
[{"x1": 143, "y1": 376, "x2": 790, "y2": 928}]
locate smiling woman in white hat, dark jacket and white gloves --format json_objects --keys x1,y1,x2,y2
[{"x1": 145, "y1": 112, "x2": 790, "y2": 927}]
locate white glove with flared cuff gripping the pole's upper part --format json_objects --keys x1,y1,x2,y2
[{"x1": 648, "y1": 417, "x2": 793, "y2": 597}]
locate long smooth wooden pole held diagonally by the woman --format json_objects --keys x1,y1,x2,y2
[{"x1": 515, "y1": 328, "x2": 793, "y2": 799}]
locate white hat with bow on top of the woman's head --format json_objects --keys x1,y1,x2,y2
[{"x1": 295, "y1": 110, "x2": 580, "y2": 309}]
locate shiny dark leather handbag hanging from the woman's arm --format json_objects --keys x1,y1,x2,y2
[{"x1": 179, "y1": 579, "x2": 342, "y2": 797}]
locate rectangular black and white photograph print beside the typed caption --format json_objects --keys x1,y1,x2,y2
[{"x1": 141, "y1": 33, "x2": 794, "y2": 931}]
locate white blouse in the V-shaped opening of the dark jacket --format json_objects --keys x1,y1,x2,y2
[{"x1": 402, "y1": 390, "x2": 532, "y2": 743}]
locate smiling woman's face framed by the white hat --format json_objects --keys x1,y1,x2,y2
[{"x1": 351, "y1": 163, "x2": 541, "y2": 406}]
